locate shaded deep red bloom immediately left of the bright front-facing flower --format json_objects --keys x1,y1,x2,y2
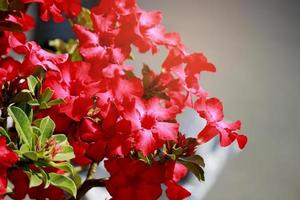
[{"x1": 71, "y1": 103, "x2": 132, "y2": 163}]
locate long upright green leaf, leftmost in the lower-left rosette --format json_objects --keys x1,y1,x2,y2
[{"x1": 7, "y1": 106, "x2": 33, "y2": 149}]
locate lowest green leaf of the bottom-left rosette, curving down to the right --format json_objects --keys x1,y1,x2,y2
[{"x1": 49, "y1": 173, "x2": 77, "y2": 197}]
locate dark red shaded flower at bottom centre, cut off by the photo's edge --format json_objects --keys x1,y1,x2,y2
[{"x1": 104, "y1": 158, "x2": 164, "y2": 200}]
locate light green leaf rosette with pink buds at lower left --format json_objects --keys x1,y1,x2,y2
[{"x1": 7, "y1": 102, "x2": 79, "y2": 196}]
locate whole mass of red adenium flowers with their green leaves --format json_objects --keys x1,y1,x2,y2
[{"x1": 0, "y1": 0, "x2": 247, "y2": 200}]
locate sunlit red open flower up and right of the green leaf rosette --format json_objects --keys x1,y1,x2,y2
[{"x1": 44, "y1": 61, "x2": 100, "y2": 121}]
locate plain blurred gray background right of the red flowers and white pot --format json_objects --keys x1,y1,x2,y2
[{"x1": 139, "y1": 0, "x2": 300, "y2": 200}]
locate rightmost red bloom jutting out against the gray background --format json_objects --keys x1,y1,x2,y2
[{"x1": 195, "y1": 98, "x2": 247, "y2": 149}]
